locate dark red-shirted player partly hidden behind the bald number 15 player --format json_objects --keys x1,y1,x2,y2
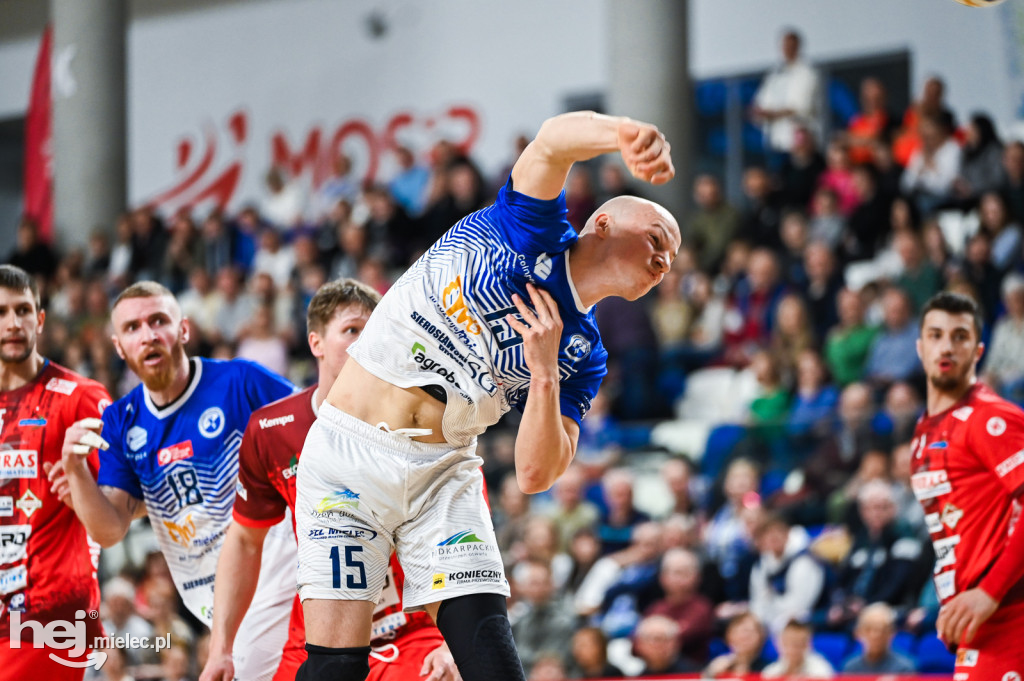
[{"x1": 201, "y1": 280, "x2": 459, "y2": 681}]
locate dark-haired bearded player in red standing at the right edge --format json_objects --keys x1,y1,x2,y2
[{"x1": 911, "y1": 293, "x2": 1024, "y2": 681}]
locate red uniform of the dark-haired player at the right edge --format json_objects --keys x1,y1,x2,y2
[{"x1": 911, "y1": 383, "x2": 1024, "y2": 681}]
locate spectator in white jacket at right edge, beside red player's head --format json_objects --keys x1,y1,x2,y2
[{"x1": 982, "y1": 273, "x2": 1024, "y2": 403}]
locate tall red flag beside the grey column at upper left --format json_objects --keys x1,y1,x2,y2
[{"x1": 25, "y1": 26, "x2": 53, "y2": 243}]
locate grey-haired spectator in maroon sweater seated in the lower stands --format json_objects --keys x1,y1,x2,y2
[{"x1": 643, "y1": 549, "x2": 715, "y2": 665}]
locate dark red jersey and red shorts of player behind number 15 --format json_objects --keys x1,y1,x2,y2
[{"x1": 232, "y1": 386, "x2": 443, "y2": 681}]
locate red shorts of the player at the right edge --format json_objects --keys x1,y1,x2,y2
[{"x1": 953, "y1": 603, "x2": 1024, "y2": 681}]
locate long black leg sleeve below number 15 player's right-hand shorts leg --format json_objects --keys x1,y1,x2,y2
[{"x1": 437, "y1": 594, "x2": 526, "y2": 681}]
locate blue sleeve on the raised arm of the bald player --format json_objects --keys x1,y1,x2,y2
[{"x1": 495, "y1": 176, "x2": 577, "y2": 253}]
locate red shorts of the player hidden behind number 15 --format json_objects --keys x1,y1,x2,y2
[{"x1": 273, "y1": 596, "x2": 444, "y2": 681}]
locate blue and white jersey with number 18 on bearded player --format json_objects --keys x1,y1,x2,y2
[{"x1": 97, "y1": 357, "x2": 294, "y2": 626}]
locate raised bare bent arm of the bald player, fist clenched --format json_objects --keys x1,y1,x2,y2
[{"x1": 512, "y1": 112, "x2": 676, "y2": 200}]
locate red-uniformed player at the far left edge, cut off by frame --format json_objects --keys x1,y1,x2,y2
[{"x1": 0, "y1": 265, "x2": 111, "y2": 681}]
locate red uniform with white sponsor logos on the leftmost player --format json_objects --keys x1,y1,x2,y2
[{"x1": 0, "y1": 360, "x2": 111, "y2": 681}]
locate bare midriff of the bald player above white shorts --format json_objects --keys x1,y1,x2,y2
[{"x1": 327, "y1": 360, "x2": 444, "y2": 442}]
